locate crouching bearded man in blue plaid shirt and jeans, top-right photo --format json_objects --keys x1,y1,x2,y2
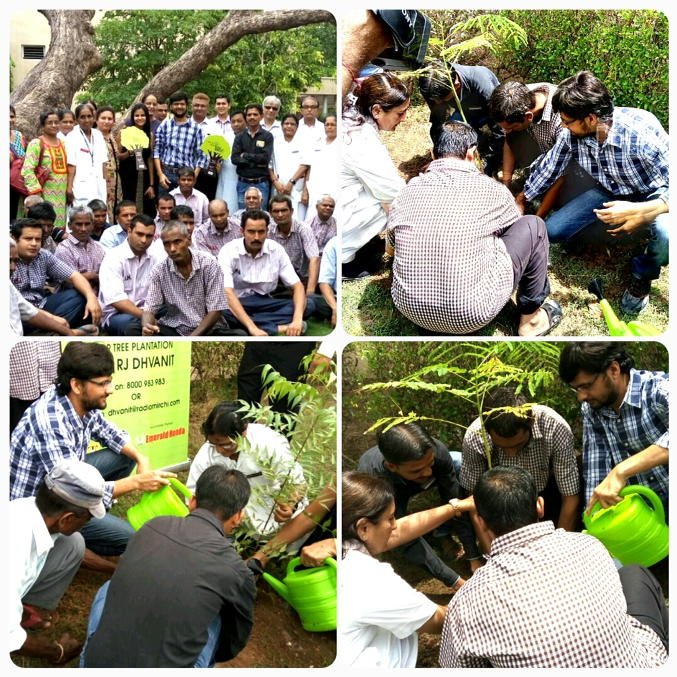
[{"x1": 516, "y1": 71, "x2": 669, "y2": 314}]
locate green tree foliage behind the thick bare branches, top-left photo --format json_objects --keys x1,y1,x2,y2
[{"x1": 78, "y1": 10, "x2": 336, "y2": 114}]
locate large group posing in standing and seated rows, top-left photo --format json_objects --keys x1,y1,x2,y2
[{"x1": 10, "y1": 91, "x2": 338, "y2": 336}]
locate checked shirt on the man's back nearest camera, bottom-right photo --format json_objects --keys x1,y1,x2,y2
[{"x1": 440, "y1": 521, "x2": 667, "y2": 668}]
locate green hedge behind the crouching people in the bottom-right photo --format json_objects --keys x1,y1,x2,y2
[{"x1": 343, "y1": 341, "x2": 669, "y2": 470}]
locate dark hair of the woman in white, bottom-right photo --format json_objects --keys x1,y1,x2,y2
[{"x1": 341, "y1": 470, "x2": 395, "y2": 554}]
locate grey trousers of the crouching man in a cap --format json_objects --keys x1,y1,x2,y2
[{"x1": 22, "y1": 533, "x2": 85, "y2": 610}]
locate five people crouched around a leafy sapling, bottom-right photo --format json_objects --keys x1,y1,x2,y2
[{"x1": 339, "y1": 342, "x2": 669, "y2": 668}]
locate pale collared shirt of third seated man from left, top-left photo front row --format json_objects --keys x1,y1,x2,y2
[{"x1": 99, "y1": 240, "x2": 164, "y2": 326}]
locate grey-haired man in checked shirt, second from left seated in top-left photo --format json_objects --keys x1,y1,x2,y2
[{"x1": 54, "y1": 206, "x2": 106, "y2": 292}]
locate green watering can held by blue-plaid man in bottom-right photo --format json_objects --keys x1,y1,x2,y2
[{"x1": 583, "y1": 484, "x2": 670, "y2": 567}]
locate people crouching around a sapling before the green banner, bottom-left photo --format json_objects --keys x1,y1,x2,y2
[{"x1": 9, "y1": 341, "x2": 336, "y2": 667}]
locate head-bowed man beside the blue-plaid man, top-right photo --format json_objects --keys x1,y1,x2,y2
[{"x1": 489, "y1": 81, "x2": 594, "y2": 207}]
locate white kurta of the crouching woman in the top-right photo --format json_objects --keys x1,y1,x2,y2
[{"x1": 340, "y1": 122, "x2": 404, "y2": 263}]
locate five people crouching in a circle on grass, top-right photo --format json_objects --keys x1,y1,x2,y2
[{"x1": 340, "y1": 62, "x2": 669, "y2": 337}]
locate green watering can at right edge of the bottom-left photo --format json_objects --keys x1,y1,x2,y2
[{"x1": 263, "y1": 557, "x2": 336, "y2": 632}]
